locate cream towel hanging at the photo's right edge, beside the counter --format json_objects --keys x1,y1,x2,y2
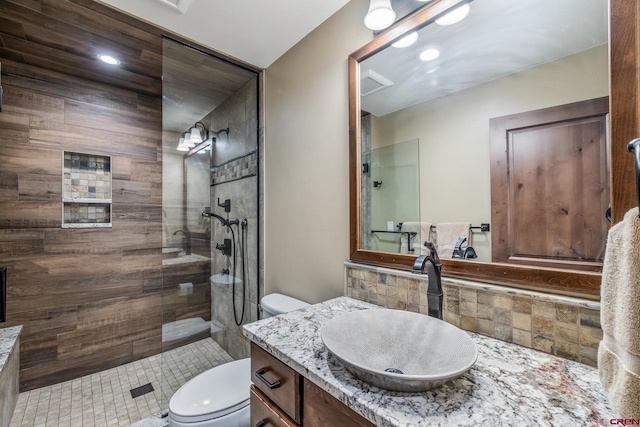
[{"x1": 598, "y1": 208, "x2": 640, "y2": 418}]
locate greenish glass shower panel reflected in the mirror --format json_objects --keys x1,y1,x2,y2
[{"x1": 362, "y1": 139, "x2": 422, "y2": 255}]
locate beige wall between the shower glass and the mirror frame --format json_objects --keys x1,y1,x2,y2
[{"x1": 264, "y1": 0, "x2": 373, "y2": 303}]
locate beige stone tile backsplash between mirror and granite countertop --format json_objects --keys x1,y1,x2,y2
[{"x1": 345, "y1": 262, "x2": 602, "y2": 366}]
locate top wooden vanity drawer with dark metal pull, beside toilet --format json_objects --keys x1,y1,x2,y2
[{"x1": 251, "y1": 343, "x2": 302, "y2": 424}]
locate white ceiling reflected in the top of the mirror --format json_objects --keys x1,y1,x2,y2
[{"x1": 360, "y1": 0, "x2": 608, "y2": 116}]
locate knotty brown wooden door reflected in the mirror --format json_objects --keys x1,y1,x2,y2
[{"x1": 490, "y1": 97, "x2": 610, "y2": 271}]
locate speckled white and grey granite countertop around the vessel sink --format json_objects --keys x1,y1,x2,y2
[{"x1": 244, "y1": 297, "x2": 614, "y2": 426}]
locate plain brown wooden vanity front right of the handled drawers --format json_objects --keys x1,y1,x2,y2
[{"x1": 304, "y1": 380, "x2": 375, "y2": 427}]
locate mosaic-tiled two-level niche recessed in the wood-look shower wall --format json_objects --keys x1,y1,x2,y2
[{"x1": 62, "y1": 151, "x2": 112, "y2": 228}]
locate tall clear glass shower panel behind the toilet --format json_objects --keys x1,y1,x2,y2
[{"x1": 161, "y1": 38, "x2": 259, "y2": 410}]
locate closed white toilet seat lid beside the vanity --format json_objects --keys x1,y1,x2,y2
[{"x1": 169, "y1": 358, "x2": 251, "y2": 423}]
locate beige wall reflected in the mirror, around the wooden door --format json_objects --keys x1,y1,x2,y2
[{"x1": 371, "y1": 45, "x2": 609, "y2": 261}]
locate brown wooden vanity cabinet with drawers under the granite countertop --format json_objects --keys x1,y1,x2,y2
[{"x1": 251, "y1": 343, "x2": 374, "y2": 427}]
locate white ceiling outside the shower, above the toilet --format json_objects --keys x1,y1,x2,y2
[{"x1": 101, "y1": 0, "x2": 350, "y2": 68}]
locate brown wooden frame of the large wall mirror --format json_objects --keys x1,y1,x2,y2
[{"x1": 348, "y1": 0, "x2": 640, "y2": 299}]
